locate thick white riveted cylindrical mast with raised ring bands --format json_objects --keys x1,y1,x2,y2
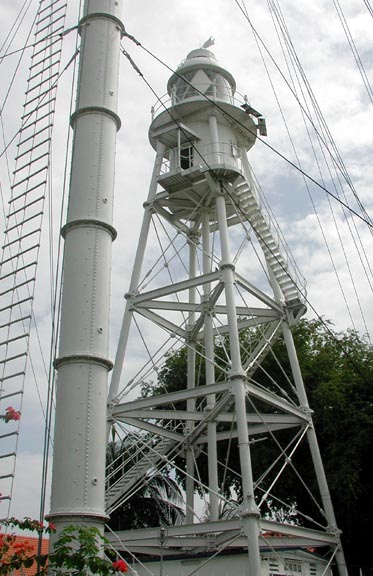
[{"x1": 49, "y1": 0, "x2": 123, "y2": 533}]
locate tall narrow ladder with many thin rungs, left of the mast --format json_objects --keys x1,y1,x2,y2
[{"x1": 0, "y1": 0, "x2": 67, "y2": 515}]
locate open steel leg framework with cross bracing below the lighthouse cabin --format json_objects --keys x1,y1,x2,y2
[{"x1": 106, "y1": 82, "x2": 338, "y2": 576}]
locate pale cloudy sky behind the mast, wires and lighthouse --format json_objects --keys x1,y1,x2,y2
[{"x1": 0, "y1": 0, "x2": 373, "y2": 517}]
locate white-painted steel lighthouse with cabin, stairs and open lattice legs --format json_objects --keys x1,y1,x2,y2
[{"x1": 107, "y1": 49, "x2": 343, "y2": 576}]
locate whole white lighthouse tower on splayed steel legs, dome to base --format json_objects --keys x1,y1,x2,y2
[{"x1": 106, "y1": 47, "x2": 345, "y2": 576}]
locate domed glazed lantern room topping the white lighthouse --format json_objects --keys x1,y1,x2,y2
[{"x1": 167, "y1": 48, "x2": 236, "y2": 104}]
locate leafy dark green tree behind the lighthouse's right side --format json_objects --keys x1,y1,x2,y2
[{"x1": 143, "y1": 320, "x2": 373, "y2": 573}]
